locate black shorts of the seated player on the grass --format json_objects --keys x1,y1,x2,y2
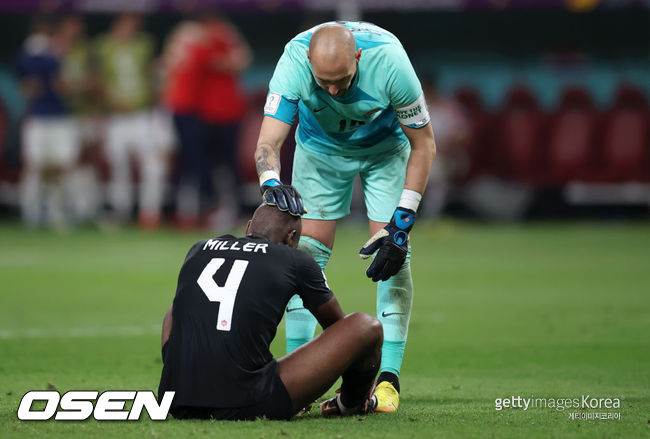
[{"x1": 170, "y1": 374, "x2": 294, "y2": 421}]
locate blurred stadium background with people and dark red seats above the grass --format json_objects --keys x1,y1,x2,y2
[{"x1": 0, "y1": 0, "x2": 650, "y2": 231}]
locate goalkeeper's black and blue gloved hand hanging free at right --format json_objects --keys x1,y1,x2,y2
[{"x1": 359, "y1": 207, "x2": 415, "y2": 282}]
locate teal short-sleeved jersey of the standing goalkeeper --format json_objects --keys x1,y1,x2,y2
[{"x1": 264, "y1": 22, "x2": 429, "y2": 156}]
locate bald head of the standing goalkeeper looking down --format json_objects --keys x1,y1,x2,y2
[{"x1": 307, "y1": 24, "x2": 361, "y2": 97}]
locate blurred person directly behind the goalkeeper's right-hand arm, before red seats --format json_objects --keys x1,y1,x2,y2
[{"x1": 420, "y1": 79, "x2": 470, "y2": 218}]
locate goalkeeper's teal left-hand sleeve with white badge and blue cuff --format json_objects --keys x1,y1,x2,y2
[{"x1": 264, "y1": 42, "x2": 304, "y2": 125}]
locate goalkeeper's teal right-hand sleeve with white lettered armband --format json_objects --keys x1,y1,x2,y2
[{"x1": 388, "y1": 47, "x2": 431, "y2": 128}]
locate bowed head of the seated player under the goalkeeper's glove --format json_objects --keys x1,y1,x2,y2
[{"x1": 246, "y1": 204, "x2": 302, "y2": 247}]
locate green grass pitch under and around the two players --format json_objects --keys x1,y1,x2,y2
[{"x1": 0, "y1": 221, "x2": 650, "y2": 439}]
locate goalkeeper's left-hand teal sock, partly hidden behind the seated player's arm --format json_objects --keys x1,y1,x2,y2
[{"x1": 285, "y1": 236, "x2": 332, "y2": 353}]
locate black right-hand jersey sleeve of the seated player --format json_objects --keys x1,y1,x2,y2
[{"x1": 296, "y1": 250, "x2": 334, "y2": 311}]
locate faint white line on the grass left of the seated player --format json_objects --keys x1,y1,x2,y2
[{"x1": 0, "y1": 325, "x2": 162, "y2": 340}]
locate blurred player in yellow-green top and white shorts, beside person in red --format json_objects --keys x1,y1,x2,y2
[{"x1": 96, "y1": 13, "x2": 169, "y2": 229}]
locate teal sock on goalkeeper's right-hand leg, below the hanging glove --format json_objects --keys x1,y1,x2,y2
[{"x1": 377, "y1": 247, "x2": 413, "y2": 376}]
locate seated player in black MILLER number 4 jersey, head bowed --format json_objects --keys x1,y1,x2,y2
[{"x1": 158, "y1": 196, "x2": 383, "y2": 420}]
